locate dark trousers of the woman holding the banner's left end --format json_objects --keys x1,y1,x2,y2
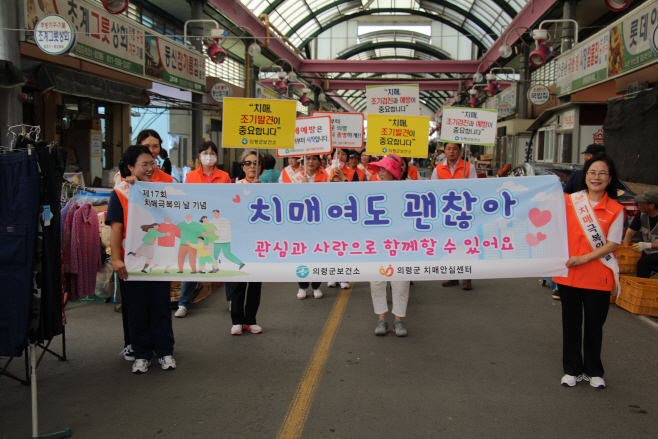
[{"x1": 119, "y1": 280, "x2": 174, "y2": 360}]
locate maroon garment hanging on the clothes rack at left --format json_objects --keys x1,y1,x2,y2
[{"x1": 69, "y1": 204, "x2": 102, "y2": 300}]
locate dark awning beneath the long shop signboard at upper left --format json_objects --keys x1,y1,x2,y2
[{"x1": 30, "y1": 64, "x2": 149, "y2": 107}]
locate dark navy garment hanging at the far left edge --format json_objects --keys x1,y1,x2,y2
[{"x1": 0, "y1": 151, "x2": 39, "y2": 357}]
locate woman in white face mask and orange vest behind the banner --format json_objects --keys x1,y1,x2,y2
[{"x1": 176, "y1": 140, "x2": 231, "y2": 318}]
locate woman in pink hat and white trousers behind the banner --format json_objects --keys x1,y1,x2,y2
[{"x1": 368, "y1": 154, "x2": 410, "y2": 337}]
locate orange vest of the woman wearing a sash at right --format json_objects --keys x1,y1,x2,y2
[{"x1": 553, "y1": 194, "x2": 624, "y2": 291}]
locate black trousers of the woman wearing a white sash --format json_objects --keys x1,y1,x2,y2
[{"x1": 558, "y1": 284, "x2": 610, "y2": 377}]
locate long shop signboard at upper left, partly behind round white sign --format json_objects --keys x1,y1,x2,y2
[{"x1": 24, "y1": 0, "x2": 206, "y2": 93}]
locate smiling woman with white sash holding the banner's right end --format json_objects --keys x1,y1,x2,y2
[{"x1": 553, "y1": 154, "x2": 624, "y2": 388}]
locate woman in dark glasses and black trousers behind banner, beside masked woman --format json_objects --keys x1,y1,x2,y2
[{"x1": 231, "y1": 149, "x2": 263, "y2": 335}]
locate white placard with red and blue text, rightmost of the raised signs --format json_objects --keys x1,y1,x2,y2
[{"x1": 441, "y1": 107, "x2": 498, "y2": 146}]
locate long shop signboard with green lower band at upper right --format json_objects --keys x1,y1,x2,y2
[{"x1": 556, "y1": 1, "x2": 658, "y2": 96}]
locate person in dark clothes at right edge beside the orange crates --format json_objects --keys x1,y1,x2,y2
[{"x1": 623, "y1": 191, "x2": 658, "y2": 279}]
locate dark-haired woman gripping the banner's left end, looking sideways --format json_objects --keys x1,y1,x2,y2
[{"x1": 105, "y1": 145, "x2": 176, "y2": 373}]
